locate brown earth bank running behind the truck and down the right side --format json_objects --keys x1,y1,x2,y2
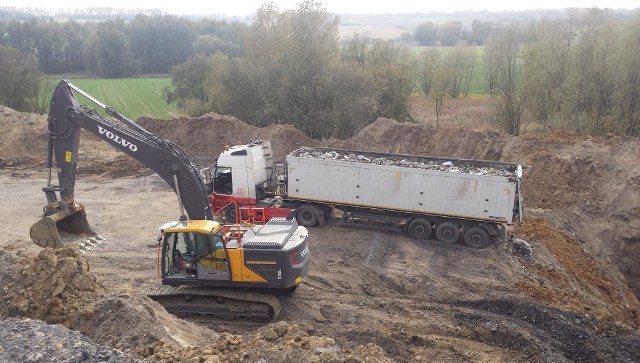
[{"x1": 0, "y1": 106, "x2": 640, "y2": 294}]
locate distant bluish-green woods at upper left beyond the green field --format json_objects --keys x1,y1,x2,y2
[{"x1": 0, "y1": 15, "x2": 246, "y2": 78}]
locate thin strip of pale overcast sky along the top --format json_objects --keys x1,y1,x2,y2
[{"x1": 6, "y1": 0, "x2": 640, "y2": 16}]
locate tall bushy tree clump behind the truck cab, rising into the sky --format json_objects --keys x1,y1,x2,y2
[{"x1": 165, "y1": 1, "x2": 413, "y2": 138}]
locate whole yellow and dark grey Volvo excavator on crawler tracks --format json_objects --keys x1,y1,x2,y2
[{"x1": 30, "y1": 80, "x2": 310, "y2": 321}]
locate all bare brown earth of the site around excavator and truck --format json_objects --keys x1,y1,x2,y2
[{"x1": 0, "y1": 99, "x2": 640, "y2": 362}]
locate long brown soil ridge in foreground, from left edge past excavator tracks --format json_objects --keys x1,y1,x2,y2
[{"x1": 0, "y1": 246, "x2": 391, "y2": 362}]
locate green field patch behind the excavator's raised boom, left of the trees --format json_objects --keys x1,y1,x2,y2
[{"x1": 43, "y1": 78, "x2": 178, "y2": 121}]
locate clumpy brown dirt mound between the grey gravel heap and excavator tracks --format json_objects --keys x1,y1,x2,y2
[{"x1": 0, "y1": 246, "x2": 218, "y2": 356}]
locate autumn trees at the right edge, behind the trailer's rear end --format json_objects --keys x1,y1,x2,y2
[{"x1": 416, "y1": 8, "x2": 640, "y2": 136}]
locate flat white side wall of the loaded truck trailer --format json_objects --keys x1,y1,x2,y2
[{"x1": 287, "y1": 155, "x2": 516, "y2": 224}]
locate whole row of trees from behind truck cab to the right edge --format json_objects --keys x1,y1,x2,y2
[{"x1": 165, "y1": 1, "x2": 640, "y2": 138}]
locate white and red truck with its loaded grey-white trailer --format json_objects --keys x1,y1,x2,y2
[{"x1": 208, "y1": 140, "x2": 524, "y2": 248}]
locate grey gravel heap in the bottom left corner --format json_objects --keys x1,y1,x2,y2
[{"x1": 0, "y1": 318, "x2": 144, "y2": 363}]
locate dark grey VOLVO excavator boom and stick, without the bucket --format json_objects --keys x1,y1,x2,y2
[{"x1": 47, "y1": 80, "x2": 212, "y2": 219}]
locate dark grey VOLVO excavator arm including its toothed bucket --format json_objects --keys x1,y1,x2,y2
[{"x1": 31, "y1": 80, "x2": 213, "y2": 247}]
